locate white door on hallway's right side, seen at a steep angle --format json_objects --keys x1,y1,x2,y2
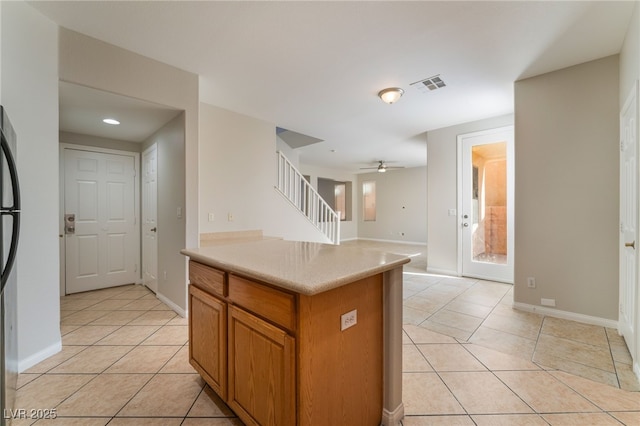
[{"x1": 142, "y1": 144, "x2": 158, "y2": 293}]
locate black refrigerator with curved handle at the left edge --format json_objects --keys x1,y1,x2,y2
[{"x1": 0, "y1": 105, "x2": 20, "y2": 425}]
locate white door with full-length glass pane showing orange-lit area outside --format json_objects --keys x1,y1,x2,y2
[{"x1": 458, "y1": 126, "x2": 514, "y2": 283}]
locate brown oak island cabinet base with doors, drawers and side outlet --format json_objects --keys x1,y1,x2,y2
[{"x1": 189, "y1": 261, "x2": 383, "y2": 426}]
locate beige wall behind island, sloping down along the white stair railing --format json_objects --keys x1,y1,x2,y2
[{"x1": 199, "y1": 103, "x2": 326, "y2": 242}]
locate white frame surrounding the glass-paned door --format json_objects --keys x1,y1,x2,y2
[{"x1": 456, "y1": 125, "x2": 515, "y2": 284}]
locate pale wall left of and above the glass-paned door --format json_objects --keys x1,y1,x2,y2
[{"x1": 427, "y1": 114, "x2": 517, "y2": 275}]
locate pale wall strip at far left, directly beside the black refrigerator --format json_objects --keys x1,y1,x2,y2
[{"x1": 0, "y1": 2, "x2": 61, "y2": 370}]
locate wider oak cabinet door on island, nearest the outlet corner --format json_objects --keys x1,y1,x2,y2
[{"x1": 228, "y1": 306, "x2": 296, "y2": 426}]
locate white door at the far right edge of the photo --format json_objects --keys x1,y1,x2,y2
[{"x1": 618, "y1": 81, "x2": 640, "y2": 365}]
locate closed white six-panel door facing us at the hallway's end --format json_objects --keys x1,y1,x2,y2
[{"x1": 64, "y1": 149, "x2": 140, "y2": 294}]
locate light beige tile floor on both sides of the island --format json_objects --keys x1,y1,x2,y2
[{"x1": 13, "y1": 241, "x2": 640, "y2": 426}]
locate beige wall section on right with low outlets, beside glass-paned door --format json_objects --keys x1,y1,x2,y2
[{"x1": 514, "y1": 55, "x2": 619, "y2": 320}]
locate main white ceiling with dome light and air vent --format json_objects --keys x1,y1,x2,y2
[{"x1": 30, "y1": 1, "x2": 635, "y2": 171}]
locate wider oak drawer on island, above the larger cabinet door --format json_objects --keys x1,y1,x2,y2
[{"x1": 229, "y1": 275, "x2": 296, "y2": 331}]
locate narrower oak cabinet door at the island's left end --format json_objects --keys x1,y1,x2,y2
[{"x1": 189, "y1": 285, "x2": 227, "y2": 399}]
